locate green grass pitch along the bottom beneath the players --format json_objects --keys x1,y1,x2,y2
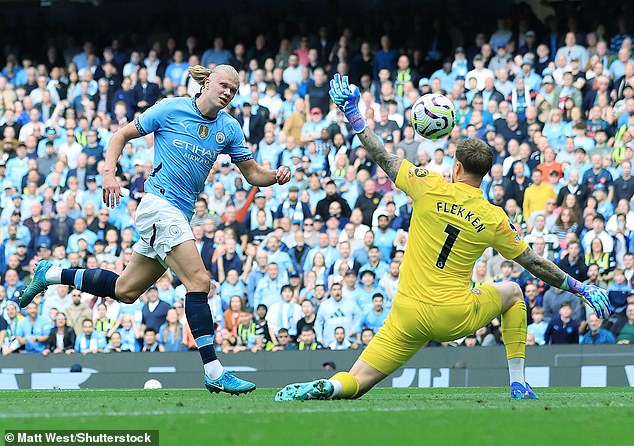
[{"x1": 0, "y1": 388, "x2": 634, "y2": 446}]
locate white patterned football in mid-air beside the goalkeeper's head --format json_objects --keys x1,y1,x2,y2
[{"x1": 412, "y1": 93, "x2": 456, "y2": 139}]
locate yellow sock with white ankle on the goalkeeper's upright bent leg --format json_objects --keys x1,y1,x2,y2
[{"x1": 502, "y1": 299, "x2": 526, "y2": 385}]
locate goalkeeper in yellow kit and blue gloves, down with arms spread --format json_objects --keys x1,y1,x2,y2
[{"x1": 275, "y1": 74, "x2": 612, "y2": 401}]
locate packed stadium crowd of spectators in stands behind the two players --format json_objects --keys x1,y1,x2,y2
[{"x1": 0, "y1": 2, "x2": 634, "y2": 355}]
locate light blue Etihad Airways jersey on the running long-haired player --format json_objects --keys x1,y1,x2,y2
[{"x1": 134, "y1": 95, "x2": 253, "y2": 220}]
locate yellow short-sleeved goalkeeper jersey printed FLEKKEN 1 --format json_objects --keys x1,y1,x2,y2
[{"x1": 396, "y1": 160, "x2": 528, "y2": 305}]
